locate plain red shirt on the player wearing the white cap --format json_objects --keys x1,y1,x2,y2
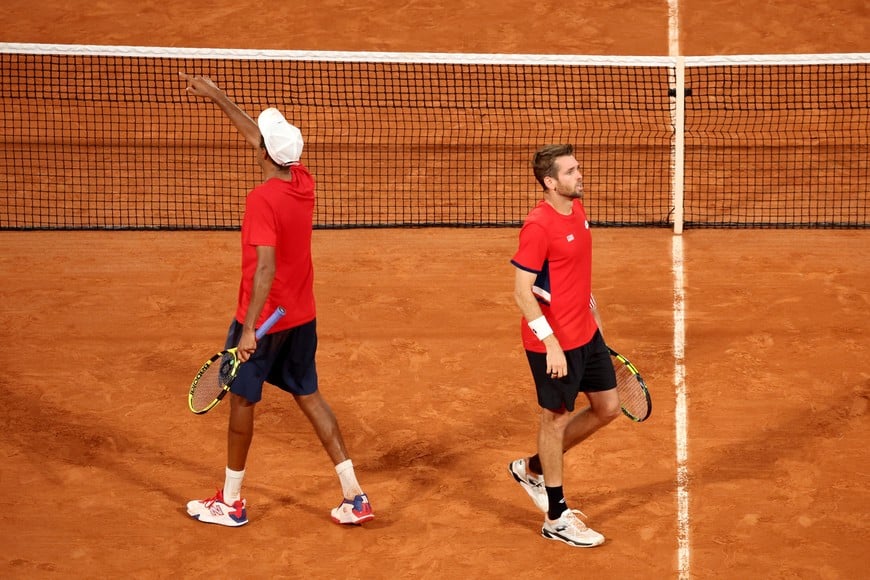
[{"x1": 236, "y1": 163, "x2": 316, "y2": 332}]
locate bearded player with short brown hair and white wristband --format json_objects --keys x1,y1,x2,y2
[{"x1": 509, "y1": 145, "x2": 620, "y2": 547}]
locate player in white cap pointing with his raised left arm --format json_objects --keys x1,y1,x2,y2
[{"x1": 181, "y1": 73, "x2": 374, "y2": 526}]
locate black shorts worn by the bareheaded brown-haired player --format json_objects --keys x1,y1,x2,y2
[{"x1": 526, "y1": 331, "x2": 616, "y2": 412}]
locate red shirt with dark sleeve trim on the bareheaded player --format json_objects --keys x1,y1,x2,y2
[{"x1": 511, "y1": 199, "x2": 598, "y2": 352}]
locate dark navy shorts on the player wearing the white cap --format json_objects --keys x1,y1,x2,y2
[{"x1": 224, "y1": 319, "x2": 317, "y2": 403}]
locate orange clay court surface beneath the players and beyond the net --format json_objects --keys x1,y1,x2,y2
[{"x1": 0, "y1": 0, "x2": 870, "y2": 579}]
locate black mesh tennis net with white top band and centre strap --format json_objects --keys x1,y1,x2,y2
[{"x1": 0, "y1": 44, "x2": 870, "y2": 229}]
